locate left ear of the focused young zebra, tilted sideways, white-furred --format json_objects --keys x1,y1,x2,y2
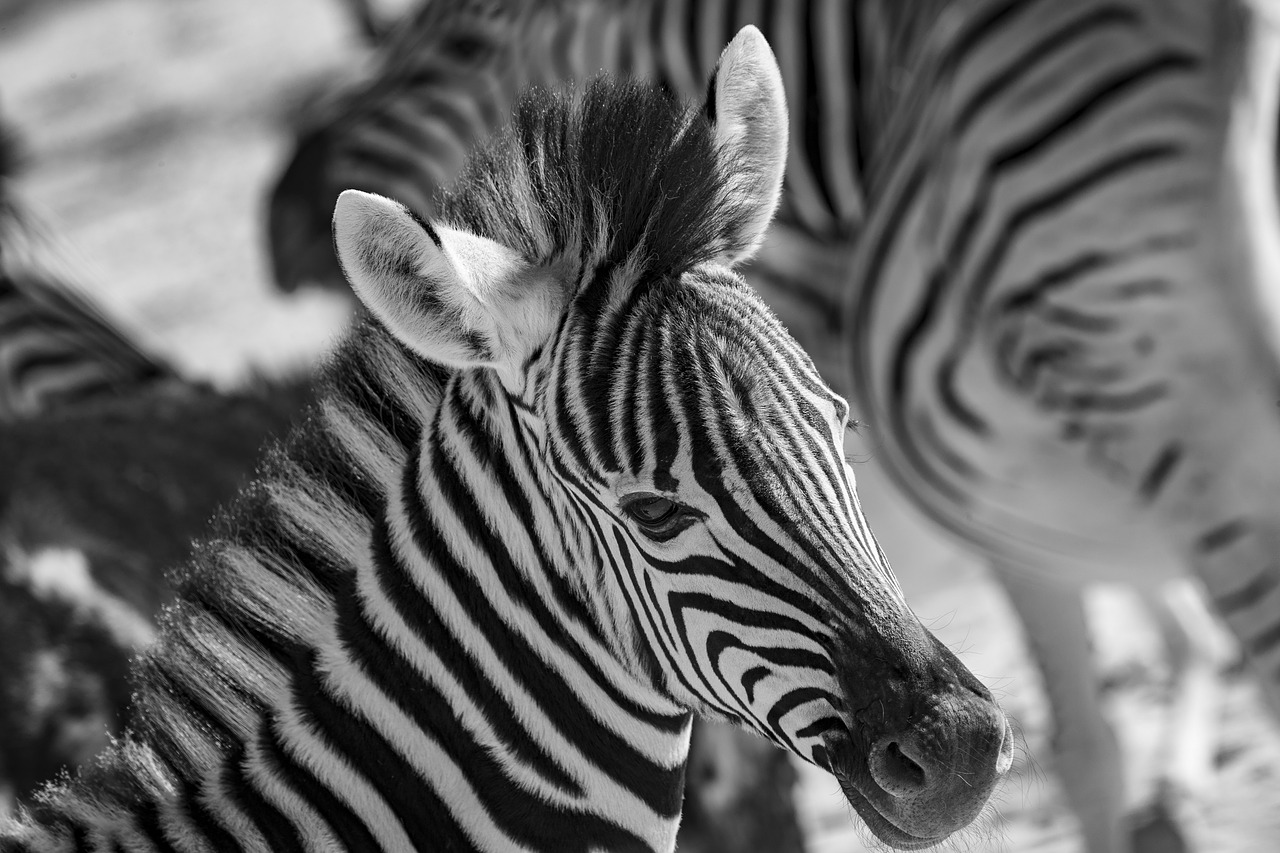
[{"x1": 333, "y1": 190, "x2": 554, "y2": 369}]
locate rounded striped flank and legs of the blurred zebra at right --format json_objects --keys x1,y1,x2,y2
[{"x1": 844, "y1": 1, "x2": 1280, "y2": 852}]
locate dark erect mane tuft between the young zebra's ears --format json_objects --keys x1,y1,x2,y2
[{"x1": 440, "y1": 78, "x2": 744, "y2": 277}]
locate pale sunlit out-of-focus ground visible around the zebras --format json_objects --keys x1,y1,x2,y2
[{"x1": 0, "y1": 0, "x2": 1280, "y2": 853}]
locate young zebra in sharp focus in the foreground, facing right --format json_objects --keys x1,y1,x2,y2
[{"x1": 0, "y1": 28, "x2": 1012, "y2": 853}]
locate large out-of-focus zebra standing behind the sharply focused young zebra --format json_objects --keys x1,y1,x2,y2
[{"x1": 264, "y1": 0, "x2": 1280, "y2": 853}]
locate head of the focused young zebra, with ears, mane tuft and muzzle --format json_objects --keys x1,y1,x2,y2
[{"x1": 334, "y1": 28, "x2": 1011, "y2": 849}]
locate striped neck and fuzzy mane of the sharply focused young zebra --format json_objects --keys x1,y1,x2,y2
[{"x1": 0, "y1": 327, "x2": 690, "y2": 853}]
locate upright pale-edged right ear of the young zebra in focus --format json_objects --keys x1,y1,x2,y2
[{"x1": 704, "y1": 26, "x2": 788, "y2": 264}]
